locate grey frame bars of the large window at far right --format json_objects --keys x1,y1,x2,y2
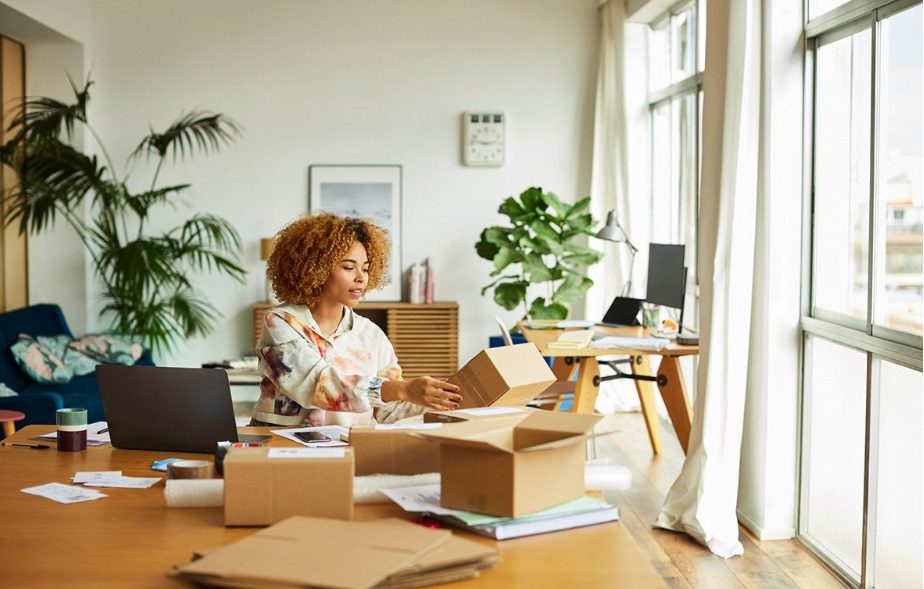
[{"x1": 796, "y1": 0, "x2": 922, "y2": 588}]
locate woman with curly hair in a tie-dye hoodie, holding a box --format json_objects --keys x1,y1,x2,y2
[{"x1": 251, "y1": 213, "x2": 462, "y2": 426}]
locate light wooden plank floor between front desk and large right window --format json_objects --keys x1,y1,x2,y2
[{"x1": 596, "y1": 413, "x2": 844, "y2": 589}]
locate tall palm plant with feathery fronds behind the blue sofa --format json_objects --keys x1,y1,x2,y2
[{"x1": 0, "y1": 80, "x2": 245, "y2": 351}]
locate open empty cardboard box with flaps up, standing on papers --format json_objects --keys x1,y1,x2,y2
[{"x1": 416, "y1": 411, "x2": 601, "y2": 517}]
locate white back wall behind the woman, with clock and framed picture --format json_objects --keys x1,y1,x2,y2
[{"x1": 74, "y1": 0, "x2": 597, "y2": 365}]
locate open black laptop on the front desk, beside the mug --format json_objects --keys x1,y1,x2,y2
[{"x1": 96, "y1": 364, "x2": 270, "y2": 454}]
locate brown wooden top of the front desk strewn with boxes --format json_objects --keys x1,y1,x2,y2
[{"x1": 0, "y1": 425, "x2": 667, "y2": 589}]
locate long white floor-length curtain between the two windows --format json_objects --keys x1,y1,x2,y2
[{"x1": 656, "y1": 0, "x2": 761, "y2": 558}]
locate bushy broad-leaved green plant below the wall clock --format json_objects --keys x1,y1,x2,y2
[{"x1": 475, "y1": 187, "x2": 603, "y2": 319}]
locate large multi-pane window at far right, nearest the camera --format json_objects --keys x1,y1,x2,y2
[{"x1": 798, "y1": 0, "x2": 924, "y2": 588}]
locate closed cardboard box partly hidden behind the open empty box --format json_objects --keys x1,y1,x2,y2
[{"x1": 350, "y1": 424, "x2": 440, "y2": 476}]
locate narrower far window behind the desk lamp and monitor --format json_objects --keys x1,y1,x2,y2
[{"x1": 648, "y1": 0, "x2": 706, "y2": 326}]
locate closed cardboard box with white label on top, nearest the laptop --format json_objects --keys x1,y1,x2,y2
[{"x1": 224, "y1": 447, "x2": 353, "y2": 526}]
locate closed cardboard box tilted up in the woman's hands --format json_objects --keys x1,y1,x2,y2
[{"x1": 449, "y1": 343, "x2": 555, "y2": 409}]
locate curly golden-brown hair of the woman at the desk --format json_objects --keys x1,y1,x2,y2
[{"x1": 266, "y1": 213, "x2": 389, "y2": 307}]
